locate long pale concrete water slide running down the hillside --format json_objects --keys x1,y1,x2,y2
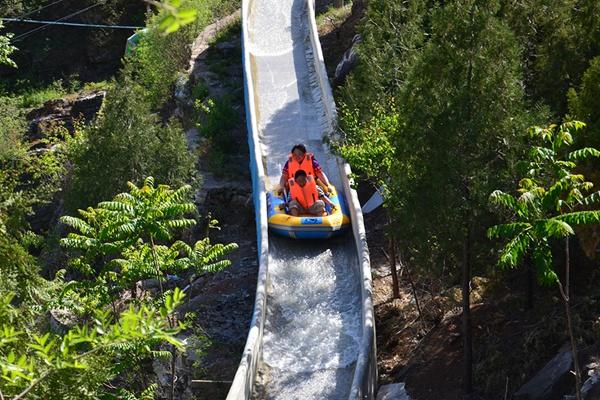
[{"x1": 227, "y1": 0, "x2": 377, "y2": 400}]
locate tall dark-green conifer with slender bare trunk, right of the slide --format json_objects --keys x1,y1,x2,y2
[{"x1": 390, "y1": 0, "x2": 527, "y2": 396}]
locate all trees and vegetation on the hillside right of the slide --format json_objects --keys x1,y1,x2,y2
[{"x1": 335, "y1": 0, "x2": 600, "y2": 399}]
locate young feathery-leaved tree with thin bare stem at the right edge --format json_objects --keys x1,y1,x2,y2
[{"x1": 488, "y1": 121, "x2": 600, "y2": 400}]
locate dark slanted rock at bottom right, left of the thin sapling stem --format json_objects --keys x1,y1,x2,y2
[{"x1": 514, "y1": 344, "x2": 574, "y2": 400}]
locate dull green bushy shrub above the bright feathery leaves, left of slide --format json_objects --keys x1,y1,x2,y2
[{"x1": 67, "y1": 78, "x2": 194, "y2": 210}]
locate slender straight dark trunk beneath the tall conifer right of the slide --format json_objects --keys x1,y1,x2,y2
[{"x1": 462, "y1": 222, "x2": 473, "y2": 400}]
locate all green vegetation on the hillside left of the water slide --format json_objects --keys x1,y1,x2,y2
[{"x1": 0, "y1": 0, "x2": 238, "y2": 399}]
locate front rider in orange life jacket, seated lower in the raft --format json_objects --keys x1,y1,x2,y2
[{"x1": 288, "y1": 169, "x2": 335, "y2": 217}]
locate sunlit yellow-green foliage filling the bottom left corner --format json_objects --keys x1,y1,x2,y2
[{"x1": 0, "y1": 179, "x2": 190, "y2": 400}]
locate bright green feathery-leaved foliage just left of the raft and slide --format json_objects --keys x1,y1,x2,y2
[{"x1": 61, "y1": 177, "x2": 237, "y2": 308}]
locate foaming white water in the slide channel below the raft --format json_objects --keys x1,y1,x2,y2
[{"x1": 263, "y1": 238, "x2": 361, "y2": 399}]
